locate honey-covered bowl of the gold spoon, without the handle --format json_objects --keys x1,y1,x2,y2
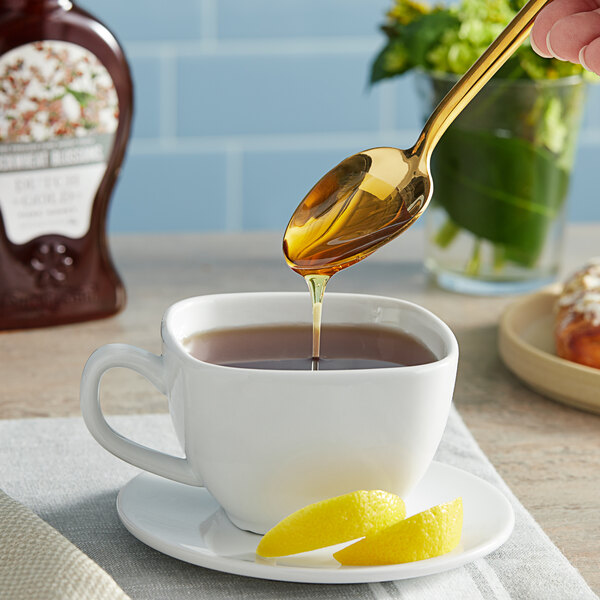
[{"x1": 283, "y1": 148, "x2": 432, "y2": 275}]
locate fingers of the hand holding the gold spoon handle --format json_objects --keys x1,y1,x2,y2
[{"x1": 531, "y1": 0, "x2": 600, "y2": 75}]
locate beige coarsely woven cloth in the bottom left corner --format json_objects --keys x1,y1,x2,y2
[{"x1": 0, "y1": 491, "x2": 128, "y2": 600}]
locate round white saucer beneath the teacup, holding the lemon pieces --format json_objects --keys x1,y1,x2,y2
[{"x1": 117, "y1": 462, "x2": 514, "y2": 583}]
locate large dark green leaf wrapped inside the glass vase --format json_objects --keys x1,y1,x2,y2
[{"x1": 431, "y1": 125, "x2": 569, "y2": 265}]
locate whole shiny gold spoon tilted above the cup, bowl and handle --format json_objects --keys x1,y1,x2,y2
[{"x1": 283, "y1": 0, "x2": 550, "y2": 276}]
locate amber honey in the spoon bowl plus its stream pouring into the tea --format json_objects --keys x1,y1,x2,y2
[{"x1": 283, "y1": 152, "x2": 424, "y2": 371}]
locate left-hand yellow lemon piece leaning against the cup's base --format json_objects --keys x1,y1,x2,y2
[{"x1": 256, "y1": 490, "x2": 406, "y2": 558}]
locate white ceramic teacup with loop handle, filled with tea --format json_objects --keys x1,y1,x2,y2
[{"x1": 81, "y1": 293, "x2": 458, "y2": 533}]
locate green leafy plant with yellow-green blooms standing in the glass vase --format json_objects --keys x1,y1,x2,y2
[{"x1": 371, "y1": 0, "x2": 595, "y2": 276}]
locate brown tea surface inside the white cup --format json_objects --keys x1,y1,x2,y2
[{"x1": 184, "y1": 325, "x2": 437, "y2": 371}]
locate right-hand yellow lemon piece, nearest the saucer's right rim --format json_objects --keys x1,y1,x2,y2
[{"x1": 333, "y1": 498, "x2": 463, "y2": 566}]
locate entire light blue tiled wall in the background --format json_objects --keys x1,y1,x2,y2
[{"x1": 72, "y1": 0, "x2": 600, "y2": 232}]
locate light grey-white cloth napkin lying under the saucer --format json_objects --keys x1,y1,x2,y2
[{"x1": 0, "y1": 410, "x2": 597, "y2": 600}]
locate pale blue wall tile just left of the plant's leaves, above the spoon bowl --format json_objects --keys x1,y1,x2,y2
[{"x1": 177, "y1": 55, "x2": 379, "y2": 137}]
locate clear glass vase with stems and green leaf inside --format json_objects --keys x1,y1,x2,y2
[{"x1": 418, "y1": 74, "x2": 585, "y2": 295}]
